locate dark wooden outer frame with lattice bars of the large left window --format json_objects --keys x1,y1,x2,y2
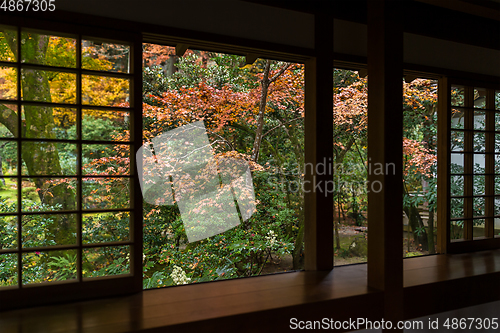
[{"x1": 0, "y1": 19, "x2": 142, "y2": 310}]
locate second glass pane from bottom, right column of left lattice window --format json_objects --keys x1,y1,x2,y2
[{"x1": 82, "y1": 212, "x2": 130, "y2": 244}]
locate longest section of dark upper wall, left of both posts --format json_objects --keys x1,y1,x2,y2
[{"x1": 56, "y1": 0, "x2": 314, "y2": 48}]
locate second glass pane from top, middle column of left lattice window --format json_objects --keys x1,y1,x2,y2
[{"x1": 21, "y1": 69, "x2": 76, "y2": 104}]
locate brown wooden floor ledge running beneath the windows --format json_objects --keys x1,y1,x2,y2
[{"x1": 0, "y1": 250, "x2": 500, "y2": 333}]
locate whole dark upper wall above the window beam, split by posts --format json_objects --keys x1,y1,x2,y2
[{"x1": 57, "y1": 0, "x2": 500, "y2": 76}]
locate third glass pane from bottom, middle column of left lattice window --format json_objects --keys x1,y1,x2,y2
[{"x1": 22, "y1": 178, "x2": 77, "y2": 212}]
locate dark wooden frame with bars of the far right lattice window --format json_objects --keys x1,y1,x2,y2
[{"x1": 438, "y1": 77, "x2": 500, "y2": 253}]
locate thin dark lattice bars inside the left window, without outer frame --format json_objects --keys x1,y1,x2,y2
[{"x1": 0, "y1": 27, "x2": 134, "y2": 290}]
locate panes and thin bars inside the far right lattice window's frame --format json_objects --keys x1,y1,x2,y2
[{"x1": 448, "y1": 85, "x2": 500, "y2": 243}]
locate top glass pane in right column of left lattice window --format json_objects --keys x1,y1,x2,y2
[{"x1": 82, "y1": 40, "x2": 130, "y2": 73}]
